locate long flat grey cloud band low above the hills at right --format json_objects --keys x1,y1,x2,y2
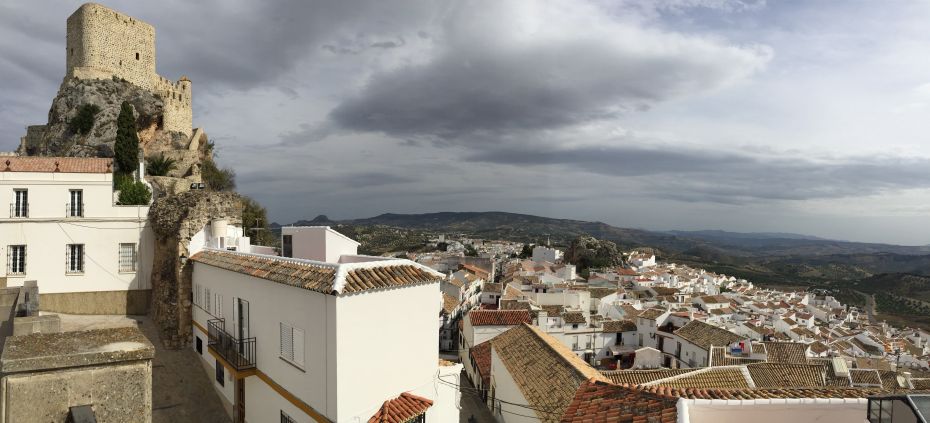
[{"x1": 469, "y1": 145, "x2": 930, "y2": 204}]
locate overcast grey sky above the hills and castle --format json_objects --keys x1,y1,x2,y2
[{"x1": 0, "y1": 0, "x2": 930, "y2": 245}]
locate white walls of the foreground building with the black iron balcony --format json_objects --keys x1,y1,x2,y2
[{"x1": 193, "y1": 248, "x2": 461, "y2": 422}]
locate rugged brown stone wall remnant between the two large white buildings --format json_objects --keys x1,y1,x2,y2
[{"x1": 149, "y1": 191, "x2": 242, "y2": 348}]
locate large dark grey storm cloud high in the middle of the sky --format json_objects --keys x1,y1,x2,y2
[{"x1": 331, "y1": 2, "x2": 770, "y2": 140}]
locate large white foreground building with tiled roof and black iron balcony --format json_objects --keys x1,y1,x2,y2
[{"x1": 190, "y1": 229, "x2": 461, "y2": 422}]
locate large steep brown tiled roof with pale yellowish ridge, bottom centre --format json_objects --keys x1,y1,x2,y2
[{"x1": 491, "y1": 325, "x2": 608, "y2": 422}]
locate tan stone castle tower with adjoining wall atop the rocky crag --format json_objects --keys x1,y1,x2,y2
[{"x1": 65, "y1": 3, "x2": 193, "y2": 137}]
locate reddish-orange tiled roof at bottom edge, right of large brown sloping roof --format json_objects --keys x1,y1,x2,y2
[{"x1": 562, "y1": 381, "x2": 678, "y2": 423}]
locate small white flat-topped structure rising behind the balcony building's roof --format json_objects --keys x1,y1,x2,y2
[{"x1": 281, "y1": 226, "x2": 360, "y2": 263}]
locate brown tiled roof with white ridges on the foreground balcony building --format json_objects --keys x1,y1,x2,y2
[{"x1": 190, "y1": 250, "x2": 442, "y2": 295}]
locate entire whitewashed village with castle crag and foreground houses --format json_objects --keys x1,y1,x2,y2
[{"x1": 0, "y1": 3, "x2": 930, "y2": 423}]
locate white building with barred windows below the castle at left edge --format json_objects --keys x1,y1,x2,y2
[{"x1": 0, "y1": 156, "x2": 154, "y2": 301}]
